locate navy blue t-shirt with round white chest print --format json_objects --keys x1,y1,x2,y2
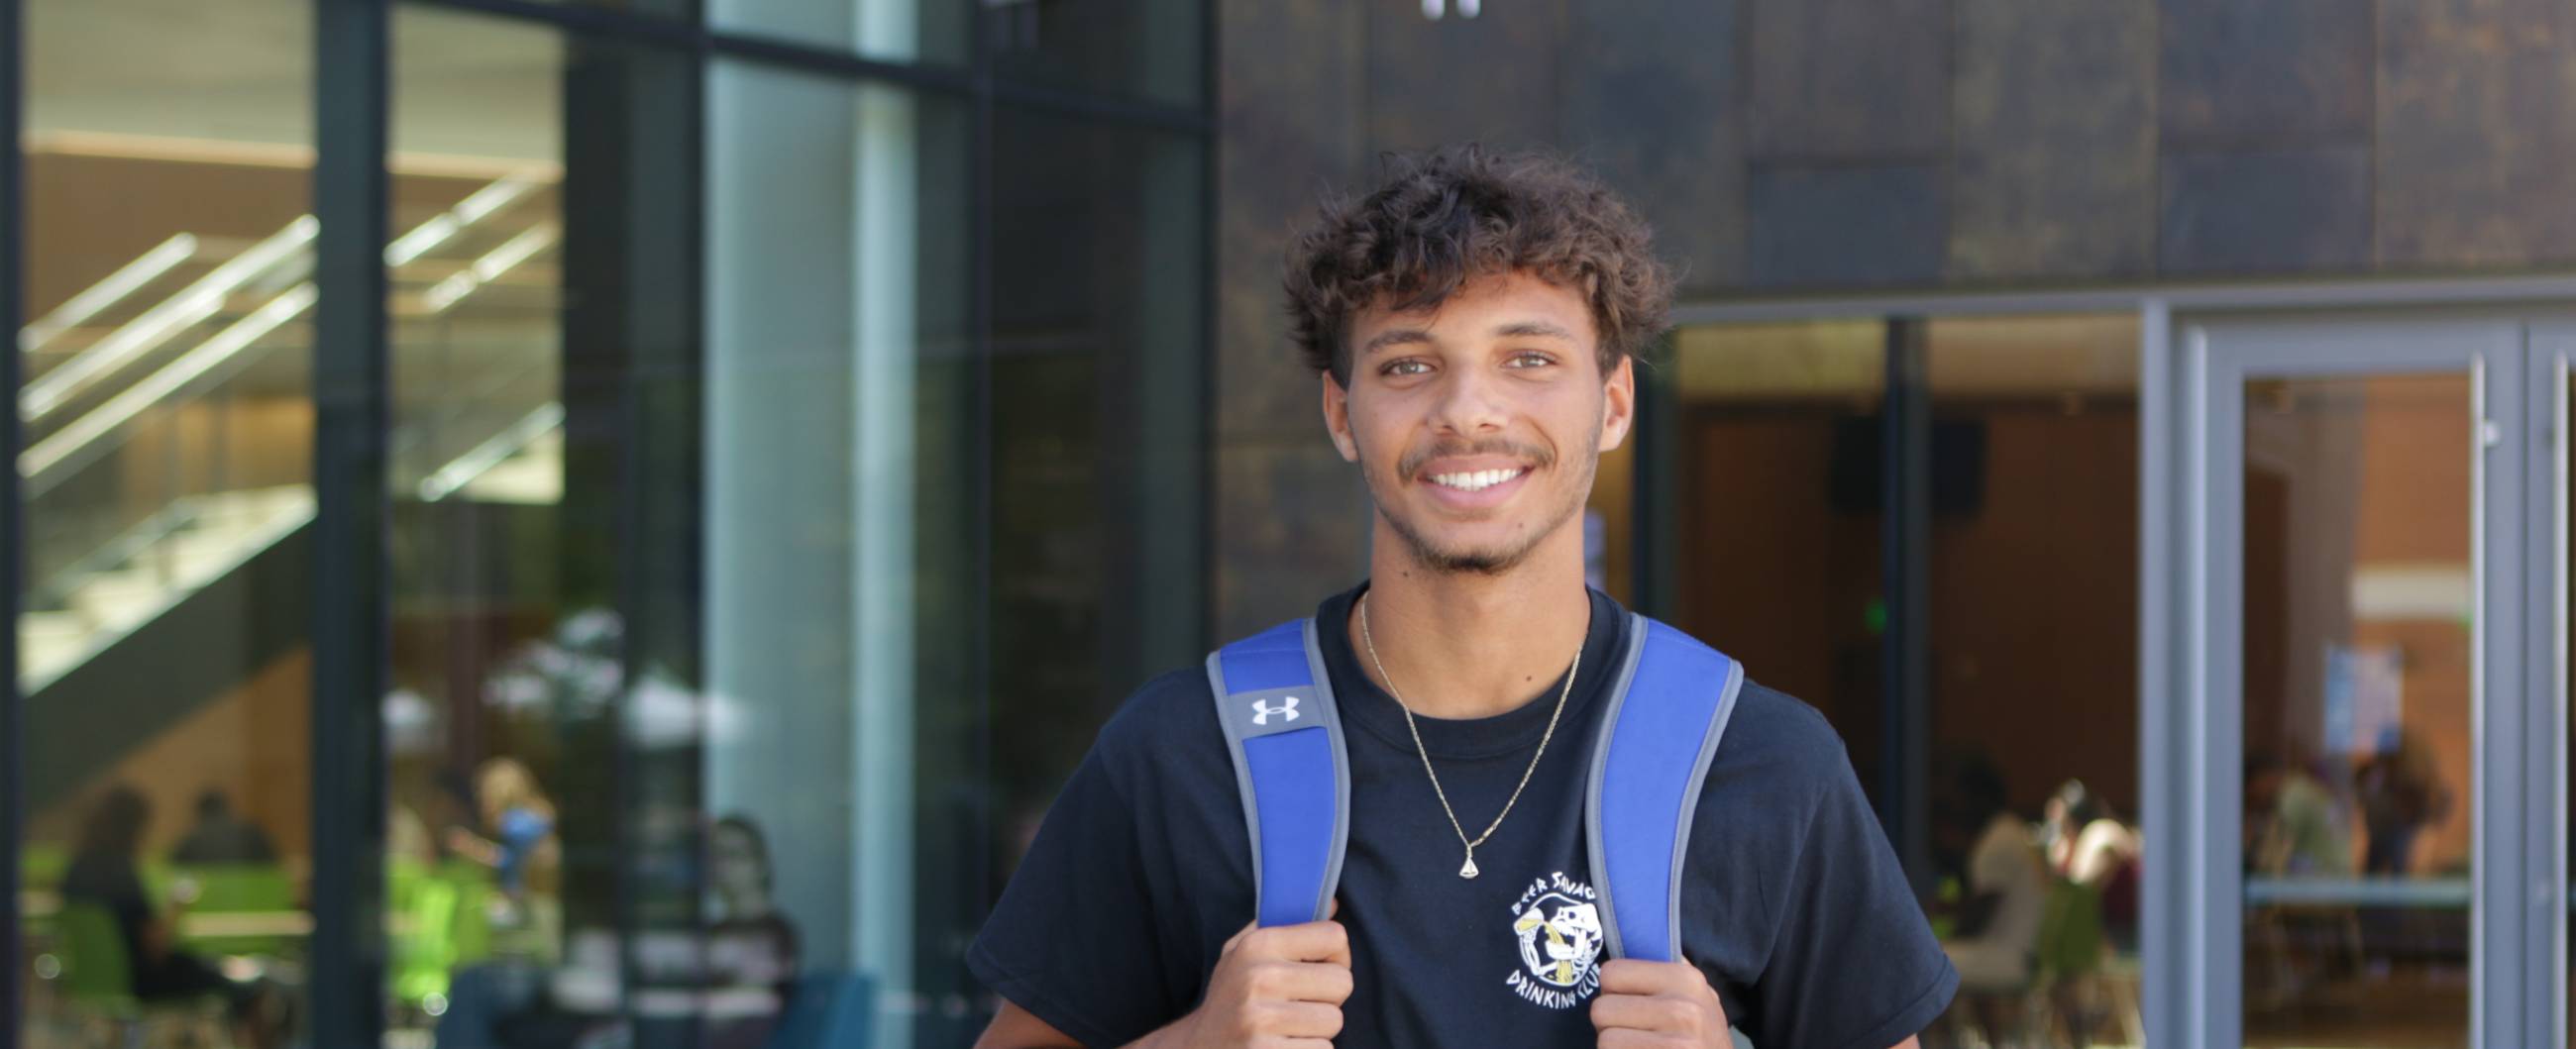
[{"x1": 966, "y1": 585, "x2": 1958, "y2": 1049}]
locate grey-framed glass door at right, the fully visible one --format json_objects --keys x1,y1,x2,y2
[{"x1": 2159, "y1": 320, "x2": 2560, "y2": 1049}]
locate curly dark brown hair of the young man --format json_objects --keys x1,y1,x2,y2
[{"x1": 1285, "y1": 145, "x2": 1671, "y2": 386}]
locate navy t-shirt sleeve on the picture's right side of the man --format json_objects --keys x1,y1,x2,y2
[{"x1": 1747, "y1": 748, "x2": 1958, "y2": 1049}]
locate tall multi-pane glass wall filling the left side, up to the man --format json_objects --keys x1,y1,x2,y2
[{"x1": 10, "y1": 0, "x2": 1211, "y2": 1049}]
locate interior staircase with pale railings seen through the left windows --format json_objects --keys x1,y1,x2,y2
[{"x1": 18, "y1": 172, "x2": 564, "y2": 804}]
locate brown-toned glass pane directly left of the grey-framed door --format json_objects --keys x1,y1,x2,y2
[{"x1": 1924, "y1": 314, "x2": 2146, "y2": 1046}]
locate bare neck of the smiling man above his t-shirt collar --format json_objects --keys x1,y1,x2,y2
[{"x1": 1349, "y1": 523, "x2": 1592, "y2": 719}]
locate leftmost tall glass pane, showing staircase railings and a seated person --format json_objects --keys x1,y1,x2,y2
[{"x1": 21, "y1": 0, "x2": 314, "y2": 1046}]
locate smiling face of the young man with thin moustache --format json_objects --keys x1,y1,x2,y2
[{"x1": 1322, "y1": 273, "x2": 1636, "y2": 575}]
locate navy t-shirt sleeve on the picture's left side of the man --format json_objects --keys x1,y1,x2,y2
[{"x1": 966, "y1": 748, "x2": 1190, "y2": 1046}]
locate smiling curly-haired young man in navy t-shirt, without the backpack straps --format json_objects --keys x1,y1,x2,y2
[{"x1": 969, "y1": 147, "x2": 1958, "y2": 1049}]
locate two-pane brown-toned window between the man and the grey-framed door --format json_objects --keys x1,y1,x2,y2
[{"x1": 1668, "y1": 314, "x2": 2143, "y2": 1044}]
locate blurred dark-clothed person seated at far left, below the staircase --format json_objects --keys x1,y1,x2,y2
[{"x1": 61, "y1": 784, "x2": 286, "y2": 1049}]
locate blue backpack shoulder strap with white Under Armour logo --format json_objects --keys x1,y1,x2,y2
[{"x1": 1208, "y1": 618, "x2": 1349, "y2": 928}]
